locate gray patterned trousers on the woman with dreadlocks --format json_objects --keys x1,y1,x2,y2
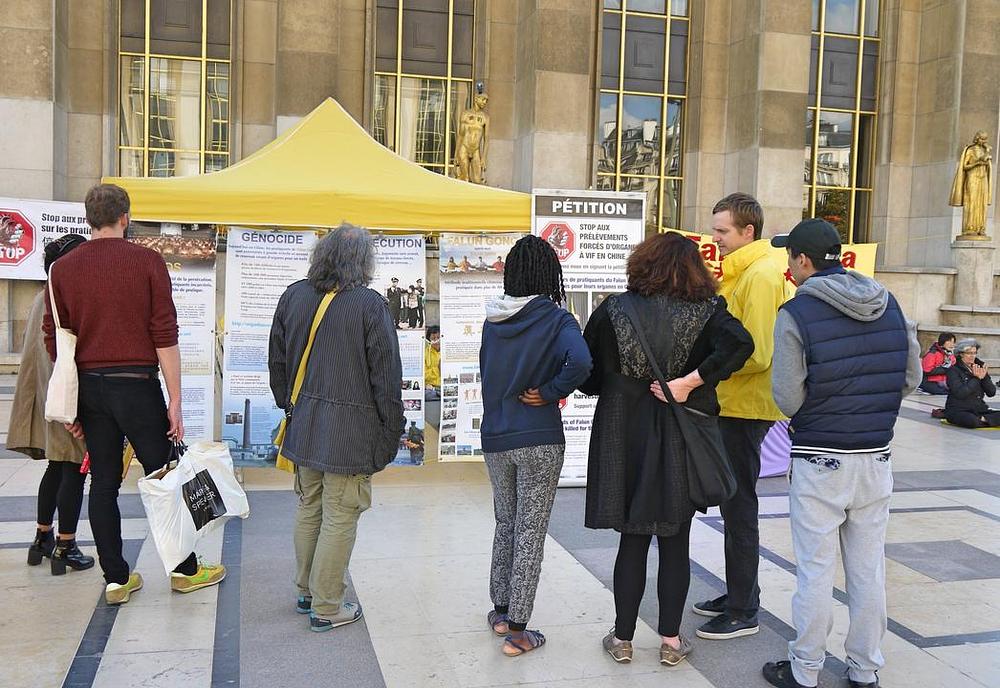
[{"x1": 486, "y1": 444, "x2": 566, "y2": 631}]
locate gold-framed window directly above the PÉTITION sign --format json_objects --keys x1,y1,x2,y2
[{"x1": 594, "y1": 0, "x2": 689, "y2": 231}]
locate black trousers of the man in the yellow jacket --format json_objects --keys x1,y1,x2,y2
[{"x1": 719, "y1": 417, "x2": 774, "y2": 621}]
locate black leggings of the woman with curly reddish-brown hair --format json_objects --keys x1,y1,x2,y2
[{"x1": 615, "y1": 521, "x2": 691, "y2": 640}]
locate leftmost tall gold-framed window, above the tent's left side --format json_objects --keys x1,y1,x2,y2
[{"x1": 118, "y1": 0, "x2": 232, "y2": 177}]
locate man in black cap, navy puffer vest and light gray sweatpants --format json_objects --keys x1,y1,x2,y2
[{"x1": 764, "y1": 218, "x2": 922, "y2": 688}]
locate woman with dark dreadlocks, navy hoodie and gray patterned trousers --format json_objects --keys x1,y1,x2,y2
[{"x1": 479, "y1": 236, "x2": 591, "y2": 657}]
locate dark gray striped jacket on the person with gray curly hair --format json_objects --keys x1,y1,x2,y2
[{"x1": 268, "y1": 280, "x2": 406, "y2": 475}]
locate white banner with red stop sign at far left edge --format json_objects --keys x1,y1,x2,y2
[{"x1": 0, "y1": 198, "x2": 90, "y2": 281}]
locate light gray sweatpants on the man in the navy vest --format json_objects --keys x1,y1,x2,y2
[{"x1": 788, "y1": 454, "x2": 892, "y2": 686}]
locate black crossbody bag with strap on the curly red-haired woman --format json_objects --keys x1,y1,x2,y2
[{"x1": 621, "y1": 293, "x2": 736, "y2": 510}]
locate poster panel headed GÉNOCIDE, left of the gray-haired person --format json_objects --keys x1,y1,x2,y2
[{"x1": 222, "y1": 227, "x2": 317, "y2": 466}]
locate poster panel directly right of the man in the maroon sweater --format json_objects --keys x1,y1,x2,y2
[{"x1": 129, "y1": 223, "x2": 216, "y2": 444}]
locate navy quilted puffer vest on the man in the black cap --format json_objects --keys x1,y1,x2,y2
[{"x1": 782, "y1": 294, "x2": 909, "y2": 455}]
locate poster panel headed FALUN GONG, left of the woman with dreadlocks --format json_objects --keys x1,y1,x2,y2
[{"x1": 438, "y1": 234, "x2": 524, "y2": 461}]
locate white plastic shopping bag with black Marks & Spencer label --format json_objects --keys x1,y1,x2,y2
[{"x1": 139, "y1": 442, "x2": 250, "y2": 574}]
